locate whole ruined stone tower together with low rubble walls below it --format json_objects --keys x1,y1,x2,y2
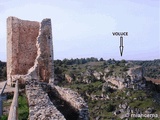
[{"x1": 7, "y1": 17, "x2": 88, "y2": 120}]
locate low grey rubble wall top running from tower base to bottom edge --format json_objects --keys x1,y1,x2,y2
[{"x1": 25, "y1": 79, "x2": 65, "y2": 120}]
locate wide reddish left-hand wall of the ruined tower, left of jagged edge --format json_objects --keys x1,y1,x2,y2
[{"x1": 7, "y1": 17, "x2": 40, "y2": 85}]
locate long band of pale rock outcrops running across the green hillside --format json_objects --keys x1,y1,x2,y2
[{"x1": 65, "y1": 66, "x2": 145, "y2": 89}]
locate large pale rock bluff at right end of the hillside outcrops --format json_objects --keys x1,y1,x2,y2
[{"x1": 105, "y1": 66, "x2": 145, "y2": 89}]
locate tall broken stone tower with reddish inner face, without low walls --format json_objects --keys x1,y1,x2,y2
[{"x1": 7, "y1": 17, "x2": 54, "y2": 85}]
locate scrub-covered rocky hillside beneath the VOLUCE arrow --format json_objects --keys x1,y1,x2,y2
[{"x1": 55, "y1": 59, "x2": 160, "y2": 120}]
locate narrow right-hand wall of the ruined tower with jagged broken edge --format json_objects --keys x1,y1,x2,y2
[{"x1": 28, "y1": 19, "x2": 54, "y2": 85}]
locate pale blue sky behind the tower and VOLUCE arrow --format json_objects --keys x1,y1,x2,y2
[{"x1": 0, "y1": 0, "x2": 160, "y2": 61}]
